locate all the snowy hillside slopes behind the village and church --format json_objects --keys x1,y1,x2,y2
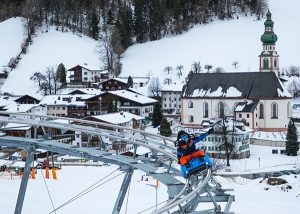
[{"x1": 0, "y1": 0, "x2": 300, "y2": 94}]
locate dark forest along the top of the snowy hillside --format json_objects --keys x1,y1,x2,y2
[{"x1": 0, "y1": 0, "x2": 268, "y2": 74}]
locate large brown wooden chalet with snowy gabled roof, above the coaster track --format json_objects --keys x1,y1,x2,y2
[{"x1": 86, "y1": 90, "x2": 157, "y2": 117}]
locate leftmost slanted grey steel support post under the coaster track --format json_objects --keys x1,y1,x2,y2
[{"x1": 15, "y1": 148, "x2": 34, "y2": 214}]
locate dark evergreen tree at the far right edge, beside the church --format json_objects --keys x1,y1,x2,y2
[{"x1": 285, "y1": 120, "x2": 299, "y2": 156}]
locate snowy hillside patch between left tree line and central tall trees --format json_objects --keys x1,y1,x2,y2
[{"x1": 0, "y1": 25, "x2": 100, "y2": 94}]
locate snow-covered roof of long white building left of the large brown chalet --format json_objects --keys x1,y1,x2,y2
[{"x1": 40, "y1": 94, "x2": 94, "y2": 106}]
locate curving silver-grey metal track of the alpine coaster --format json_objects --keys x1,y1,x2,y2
[{"x1": 0, "y1": 112, "x2": 234, "y2": 214}]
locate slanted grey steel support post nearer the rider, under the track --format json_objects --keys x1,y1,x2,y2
[{"x1": 112, "y1": 169, "x2": 133, "y2": 214}]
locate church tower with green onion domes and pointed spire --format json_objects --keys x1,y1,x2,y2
[{"x1": 259, "y1": 10, "x2": 279, "y2": 74}]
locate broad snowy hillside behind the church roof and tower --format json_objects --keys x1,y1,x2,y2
[{"x1": 122, "y1": 0, "x2": 300, "y2": 79}]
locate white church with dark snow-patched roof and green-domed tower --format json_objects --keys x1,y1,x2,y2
[{"x1": 181, "y1": 11, "x2": 292, "y2": 131}]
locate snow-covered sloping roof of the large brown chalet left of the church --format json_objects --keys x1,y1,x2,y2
[{"x1": 108, "y1": 90, "x2": 157, "y2": 104}]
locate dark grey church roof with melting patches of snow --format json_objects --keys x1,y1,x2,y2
[{"x1": 182, "y1": 72, "x2": 292, "y2": 99}]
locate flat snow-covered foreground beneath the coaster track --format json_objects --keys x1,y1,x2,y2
[{"x1": 0, "y1": 159, "x2": 300, "y2": 214}]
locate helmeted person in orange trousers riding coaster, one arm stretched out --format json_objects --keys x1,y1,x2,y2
[{"x1": 175, "y1": 128, "x2": 214, "y2": 168}]
